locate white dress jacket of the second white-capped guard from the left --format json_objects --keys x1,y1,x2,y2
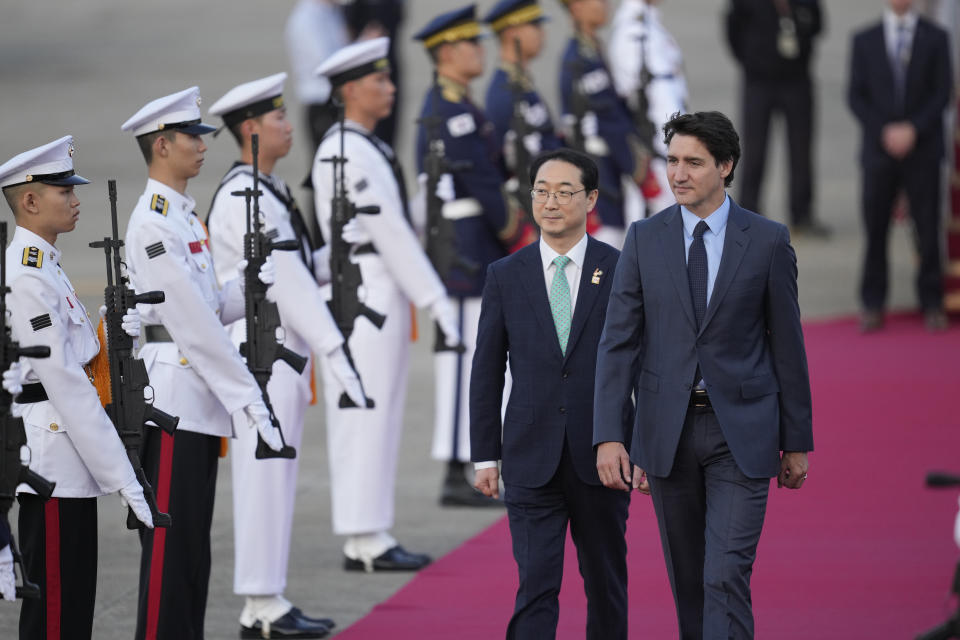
[{"x1": 126, "y1": 179, "x2": 260, "y2": 437}]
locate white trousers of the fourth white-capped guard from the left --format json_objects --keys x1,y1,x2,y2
[{"x1": 321, "y1": 255, "x2": 410, "y2": 536}]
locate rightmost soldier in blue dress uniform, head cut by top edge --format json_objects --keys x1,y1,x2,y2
[{"x1": 560, "y1": 0, "x2": 649, "y2": 248}]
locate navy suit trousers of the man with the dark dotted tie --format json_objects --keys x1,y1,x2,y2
[{"x1": 649, "y1": 408, "x2": 770, "y2": 640}]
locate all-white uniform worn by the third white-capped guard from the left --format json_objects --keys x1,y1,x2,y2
[{"x1": 208, "y1": 163, "x2": 343, "y2": 595}]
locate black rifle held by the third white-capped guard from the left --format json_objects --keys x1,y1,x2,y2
[{"x1": 321, "y1": 101, "x2": 387, "y2": 409}]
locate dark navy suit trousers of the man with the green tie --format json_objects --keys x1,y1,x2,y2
[{"x1": 504, "y1": 442, "x2": 630, "y2": 640}]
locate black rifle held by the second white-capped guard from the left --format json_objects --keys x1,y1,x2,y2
[{"x1": 230, "y1": 133, "x2": 307, "y2": 460}]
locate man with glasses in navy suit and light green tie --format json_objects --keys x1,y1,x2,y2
[{"x1": 470, "y1": 149, "x2": 630, "y2": 640}]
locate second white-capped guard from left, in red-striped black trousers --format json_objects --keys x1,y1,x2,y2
[{"x1": 121, "y1": 87, "x2": 281, "y2": 640}]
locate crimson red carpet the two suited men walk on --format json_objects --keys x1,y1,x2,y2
[{"x1": 338, "y1": 316, "x2": 960, "y2": 640}]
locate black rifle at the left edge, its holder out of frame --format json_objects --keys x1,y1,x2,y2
[{"x1": 0, "y1": 222, "x2": 56, "y2": 598}]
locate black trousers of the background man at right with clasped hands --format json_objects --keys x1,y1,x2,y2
[{"x1": 860, "y1": 157, "x2": 943, "y2": 311}]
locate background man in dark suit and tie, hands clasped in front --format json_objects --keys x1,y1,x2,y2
[{"x1": 847, "y1": 0, "x2": 951, "y2": 332}]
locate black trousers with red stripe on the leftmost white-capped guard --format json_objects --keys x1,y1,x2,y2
[{"x1": 17, "y1": 493, "x2": 97, "y2": 640}]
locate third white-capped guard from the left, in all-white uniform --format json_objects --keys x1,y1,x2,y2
[{"x1": 207, "y1": 73, "x2": 365, "y2": 638}]
